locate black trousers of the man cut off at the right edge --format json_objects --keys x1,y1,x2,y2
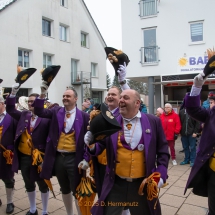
[{"x1": 208, "y1": 167, "x2": 215, "y2": 215}]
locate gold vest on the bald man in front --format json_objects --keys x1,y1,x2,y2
[{"x1": 116, "y1": 135, "x2": 146, "y2": 178}]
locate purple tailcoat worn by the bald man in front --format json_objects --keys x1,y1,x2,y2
[{"x1": 91, "y1": 113, "x2": 169, "y2": 215}]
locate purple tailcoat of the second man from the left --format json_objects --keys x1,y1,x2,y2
[{"x1": 6, "y1": 97, "x2": 50, "y2": 181}]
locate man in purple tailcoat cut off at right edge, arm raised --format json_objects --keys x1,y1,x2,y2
[{"x1": 184, "y1": 72, "x2": 215, "y2": 215}]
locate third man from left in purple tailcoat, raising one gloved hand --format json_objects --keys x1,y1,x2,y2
[{"x1": 34, "y1": 85, "x2": 89, "y2": 215}]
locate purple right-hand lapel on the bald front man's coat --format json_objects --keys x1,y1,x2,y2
[{"x1": 141, "y1": 113, "x2": 152, "y2": 159}]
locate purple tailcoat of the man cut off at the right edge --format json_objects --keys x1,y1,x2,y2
[{"x1": 184, "y1": 94, "x2": 215, "y2": 197}]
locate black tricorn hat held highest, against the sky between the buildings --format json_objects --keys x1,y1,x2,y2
[{"x1": 105, "y1": 47, "x2": 130, "y2": 75}]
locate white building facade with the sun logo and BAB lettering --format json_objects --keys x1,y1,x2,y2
[{"x1": 121, "y1": 0, "x2": 215, "y2": 113}]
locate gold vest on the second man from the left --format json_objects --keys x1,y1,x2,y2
[{"x1": 18, "y1": 129, "x2": 33, "y2": 155}]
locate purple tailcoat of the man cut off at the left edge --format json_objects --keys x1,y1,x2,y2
[{"x1": 0, "y1": 114, "x2": 16, "y2": 179}]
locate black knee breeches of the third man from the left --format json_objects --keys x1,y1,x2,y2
[{"x1": 54, "y1": 152, "x2": 76, "y2": 194}]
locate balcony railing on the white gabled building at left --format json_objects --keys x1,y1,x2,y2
[{"x1": 71, "y1": 71, "x2": 91, "y2": 85}]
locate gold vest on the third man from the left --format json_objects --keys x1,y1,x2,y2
[{"x1": 57, "y1": 131, "x2": 76, "y2": 152}]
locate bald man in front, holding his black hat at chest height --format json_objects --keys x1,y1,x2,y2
[{"x1": 85, "y1": 90, "x2": 169, "y2": 215}]
